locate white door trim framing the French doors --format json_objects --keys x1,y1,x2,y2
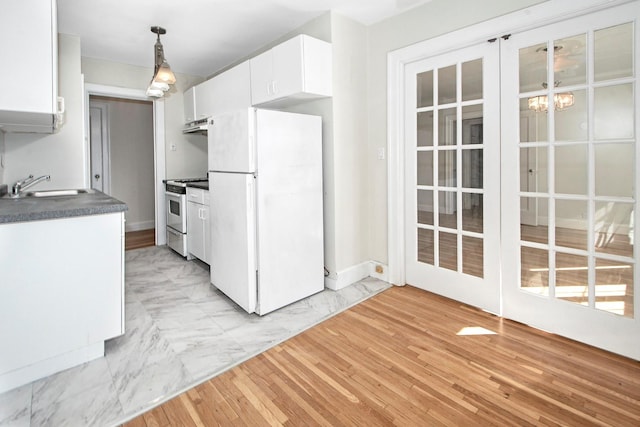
[{"x1": 387, "y1": 0, "x2": 638, "y2": 285}]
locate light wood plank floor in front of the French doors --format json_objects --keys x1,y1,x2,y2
[{"x1": 126, "y1": 286, "x2": 640, "y2": 427}]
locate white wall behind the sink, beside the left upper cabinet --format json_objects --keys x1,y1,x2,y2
[{"x1": 4, "y1": 34, "x2": 85, "y2": 189}]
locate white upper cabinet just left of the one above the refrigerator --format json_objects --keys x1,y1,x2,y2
[{"x1": 195, "y1": 61, "x2": 251, "y2": 119}]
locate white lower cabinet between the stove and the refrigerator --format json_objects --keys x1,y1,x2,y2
[{"x1": 187, "y1": 187, "x2": 211, "y2": 264}]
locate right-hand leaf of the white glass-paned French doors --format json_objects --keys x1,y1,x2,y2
[{"x1": 501, "y1": 2, "x2": 640, "y2": 359}]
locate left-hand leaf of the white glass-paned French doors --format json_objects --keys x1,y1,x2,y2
[{"x1": 404, "y1": 42, "x2": 500, "y2": 313}]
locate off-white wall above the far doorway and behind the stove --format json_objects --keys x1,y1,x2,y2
[{"x1": 82, "y1": 58, "x2": 207, "y2": 178}]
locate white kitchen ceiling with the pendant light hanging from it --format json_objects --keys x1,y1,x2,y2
[{"x1": 58, "y1": 0, "x2": 431, "y2": 77}]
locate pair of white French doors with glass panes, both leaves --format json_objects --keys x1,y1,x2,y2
[{"x1": 404, "y1": 2, "x2": 640, "y2": 360}]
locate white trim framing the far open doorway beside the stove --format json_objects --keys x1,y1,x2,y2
[{"x1": 84, "y1": 83, "x2": 167, "y2": 245}]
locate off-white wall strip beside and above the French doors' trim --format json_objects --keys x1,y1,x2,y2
[{"x1": 363, "y1": 0, "x2": 545, "y2": 264}]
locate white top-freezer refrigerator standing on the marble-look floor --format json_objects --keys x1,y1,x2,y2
[{"x1": 208, "y1": 108, "x2": 324, "y2": 315}]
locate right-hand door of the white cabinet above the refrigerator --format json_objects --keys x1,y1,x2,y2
[{"x1": 271, "y1": 36, "x2": 304, "y2": 99}]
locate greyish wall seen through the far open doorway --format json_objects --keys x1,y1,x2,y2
[{"x1": 91, "y1": 97, "x2": 155, "y2": 231}]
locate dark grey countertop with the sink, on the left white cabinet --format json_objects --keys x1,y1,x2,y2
[{"x1": 0, "y1": 191, "x2": 128, "y2": 224}]
